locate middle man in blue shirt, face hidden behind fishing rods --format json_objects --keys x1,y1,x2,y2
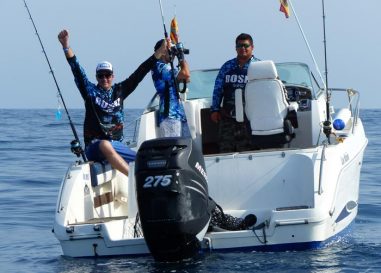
[{"x1": 151, "y1": 39, "x2": 190, "y2": 137}]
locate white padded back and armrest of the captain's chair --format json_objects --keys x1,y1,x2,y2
[{"x1": 236, "y1": 61, "x2": 295, "y2": 149}]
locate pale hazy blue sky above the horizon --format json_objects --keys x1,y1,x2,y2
[{"x1": 0, "y1": 0, "x2": 381, "y2": 109}]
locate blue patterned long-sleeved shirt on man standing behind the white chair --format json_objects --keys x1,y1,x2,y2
[{"x1": 211, "y1": 56, "x2": 259, "y2": 114}]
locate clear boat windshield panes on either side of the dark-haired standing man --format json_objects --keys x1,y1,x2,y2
[{"x1": 187, "y1": 63, "x2": 317, "y2": 99}]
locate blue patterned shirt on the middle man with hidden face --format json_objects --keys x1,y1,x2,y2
[{"x1": 151, "y1": 60, "x2": 186, "y2": 124}]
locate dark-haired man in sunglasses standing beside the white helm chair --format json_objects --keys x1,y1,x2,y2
[{"x1": 211, "y1": 33, "x2": 259, "y2": 152}]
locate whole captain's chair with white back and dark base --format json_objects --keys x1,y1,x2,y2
[{"x1": 235, "y1": 61, "x2": 297, "y2": 149}]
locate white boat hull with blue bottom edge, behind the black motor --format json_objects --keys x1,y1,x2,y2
[{"x1": 54, "y1": 129, "x2": 366, "y2": 257}]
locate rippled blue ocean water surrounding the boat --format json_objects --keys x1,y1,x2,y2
[{"x1": 0, "y1": 109, "x2": 381, "y2": 273}]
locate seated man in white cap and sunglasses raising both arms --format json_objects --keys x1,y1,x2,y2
[{"x1": 58, "y1": 30, "x2": 166, "y2": 175}]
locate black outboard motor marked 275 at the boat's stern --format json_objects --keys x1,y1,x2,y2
[{"x1": 135, "y1": 138, "x2": 215, "y2": 261}]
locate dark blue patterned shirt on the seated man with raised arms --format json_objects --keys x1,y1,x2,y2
[{"x1": 67, "y1": 55, "x2": 156, "y2": 145}]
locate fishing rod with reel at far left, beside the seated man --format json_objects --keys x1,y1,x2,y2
[{"x1": 23, "y1": 0, "x2": 87, "y2": 162}]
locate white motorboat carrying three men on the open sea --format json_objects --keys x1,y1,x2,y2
[{"x1": 54, "y1": 58, "x2": 367, "y2": 259}]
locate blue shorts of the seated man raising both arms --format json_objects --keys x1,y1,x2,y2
[{"x1": 85, "y1": 140, "x2": 136, "y2": 163}]
